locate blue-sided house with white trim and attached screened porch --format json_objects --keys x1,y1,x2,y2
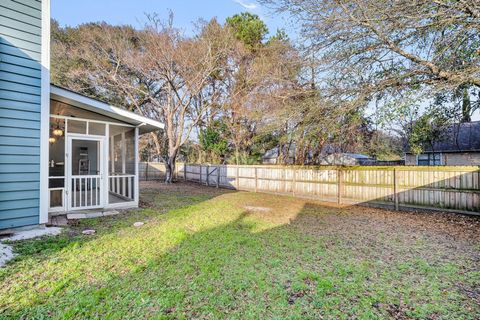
[{"x1": 0, "y1": 0, "x2": 163, "y2": 229}]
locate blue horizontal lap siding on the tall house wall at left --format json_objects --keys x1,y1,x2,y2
[{"x1": 0, "y1": 0, "x2": 42, "y2": 229}]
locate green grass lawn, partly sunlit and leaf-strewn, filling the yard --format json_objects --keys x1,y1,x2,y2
[{"x1": 0, "y1": 183, "x2": 480, "y2": 319}]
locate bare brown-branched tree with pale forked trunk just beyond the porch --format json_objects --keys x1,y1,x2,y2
[{"x1": 52, "y1": 15, "x2": 229, "y2": 182}]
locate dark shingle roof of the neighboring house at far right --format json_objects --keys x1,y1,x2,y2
[{"x1": 425, "y1": 121, "x2": 480, "y2": 152}]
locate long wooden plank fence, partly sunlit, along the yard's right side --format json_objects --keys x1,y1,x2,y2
[{"x1": 177, "y1": 164, "x2": 480, "y2": 214}]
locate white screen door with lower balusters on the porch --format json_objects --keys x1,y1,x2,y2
[{"x1": 68, "y1": 137, "x2": 104, "y2": 210}]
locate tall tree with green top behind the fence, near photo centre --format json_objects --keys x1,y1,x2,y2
[{"x1": 206, "y1": 14, "x2": 300, "y2": 164}]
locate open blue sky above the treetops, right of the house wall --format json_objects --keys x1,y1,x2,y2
[{"x1": 51, "y1": 0, "x2": 294, "y2": 38}]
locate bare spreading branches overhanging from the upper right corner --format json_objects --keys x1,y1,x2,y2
[{"x1": 261, "y1": 0, "x2": 480, "y2": 103}]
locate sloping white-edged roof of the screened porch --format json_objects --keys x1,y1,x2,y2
[{"x1": 50, "y1": 84, "x2": 165, "y2": 134}]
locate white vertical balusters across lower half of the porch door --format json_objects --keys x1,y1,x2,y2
[{"x1": 71, "y1": 175, "x2": 101, "y2": 209}]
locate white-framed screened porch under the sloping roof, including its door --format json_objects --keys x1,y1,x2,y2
[{"x1": 49, "y1": 100, "x2": 138, "y2": 212}]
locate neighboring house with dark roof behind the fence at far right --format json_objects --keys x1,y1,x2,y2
[{"x1": 405, "y1": 121, "x2": 480, "y2": 166}]
